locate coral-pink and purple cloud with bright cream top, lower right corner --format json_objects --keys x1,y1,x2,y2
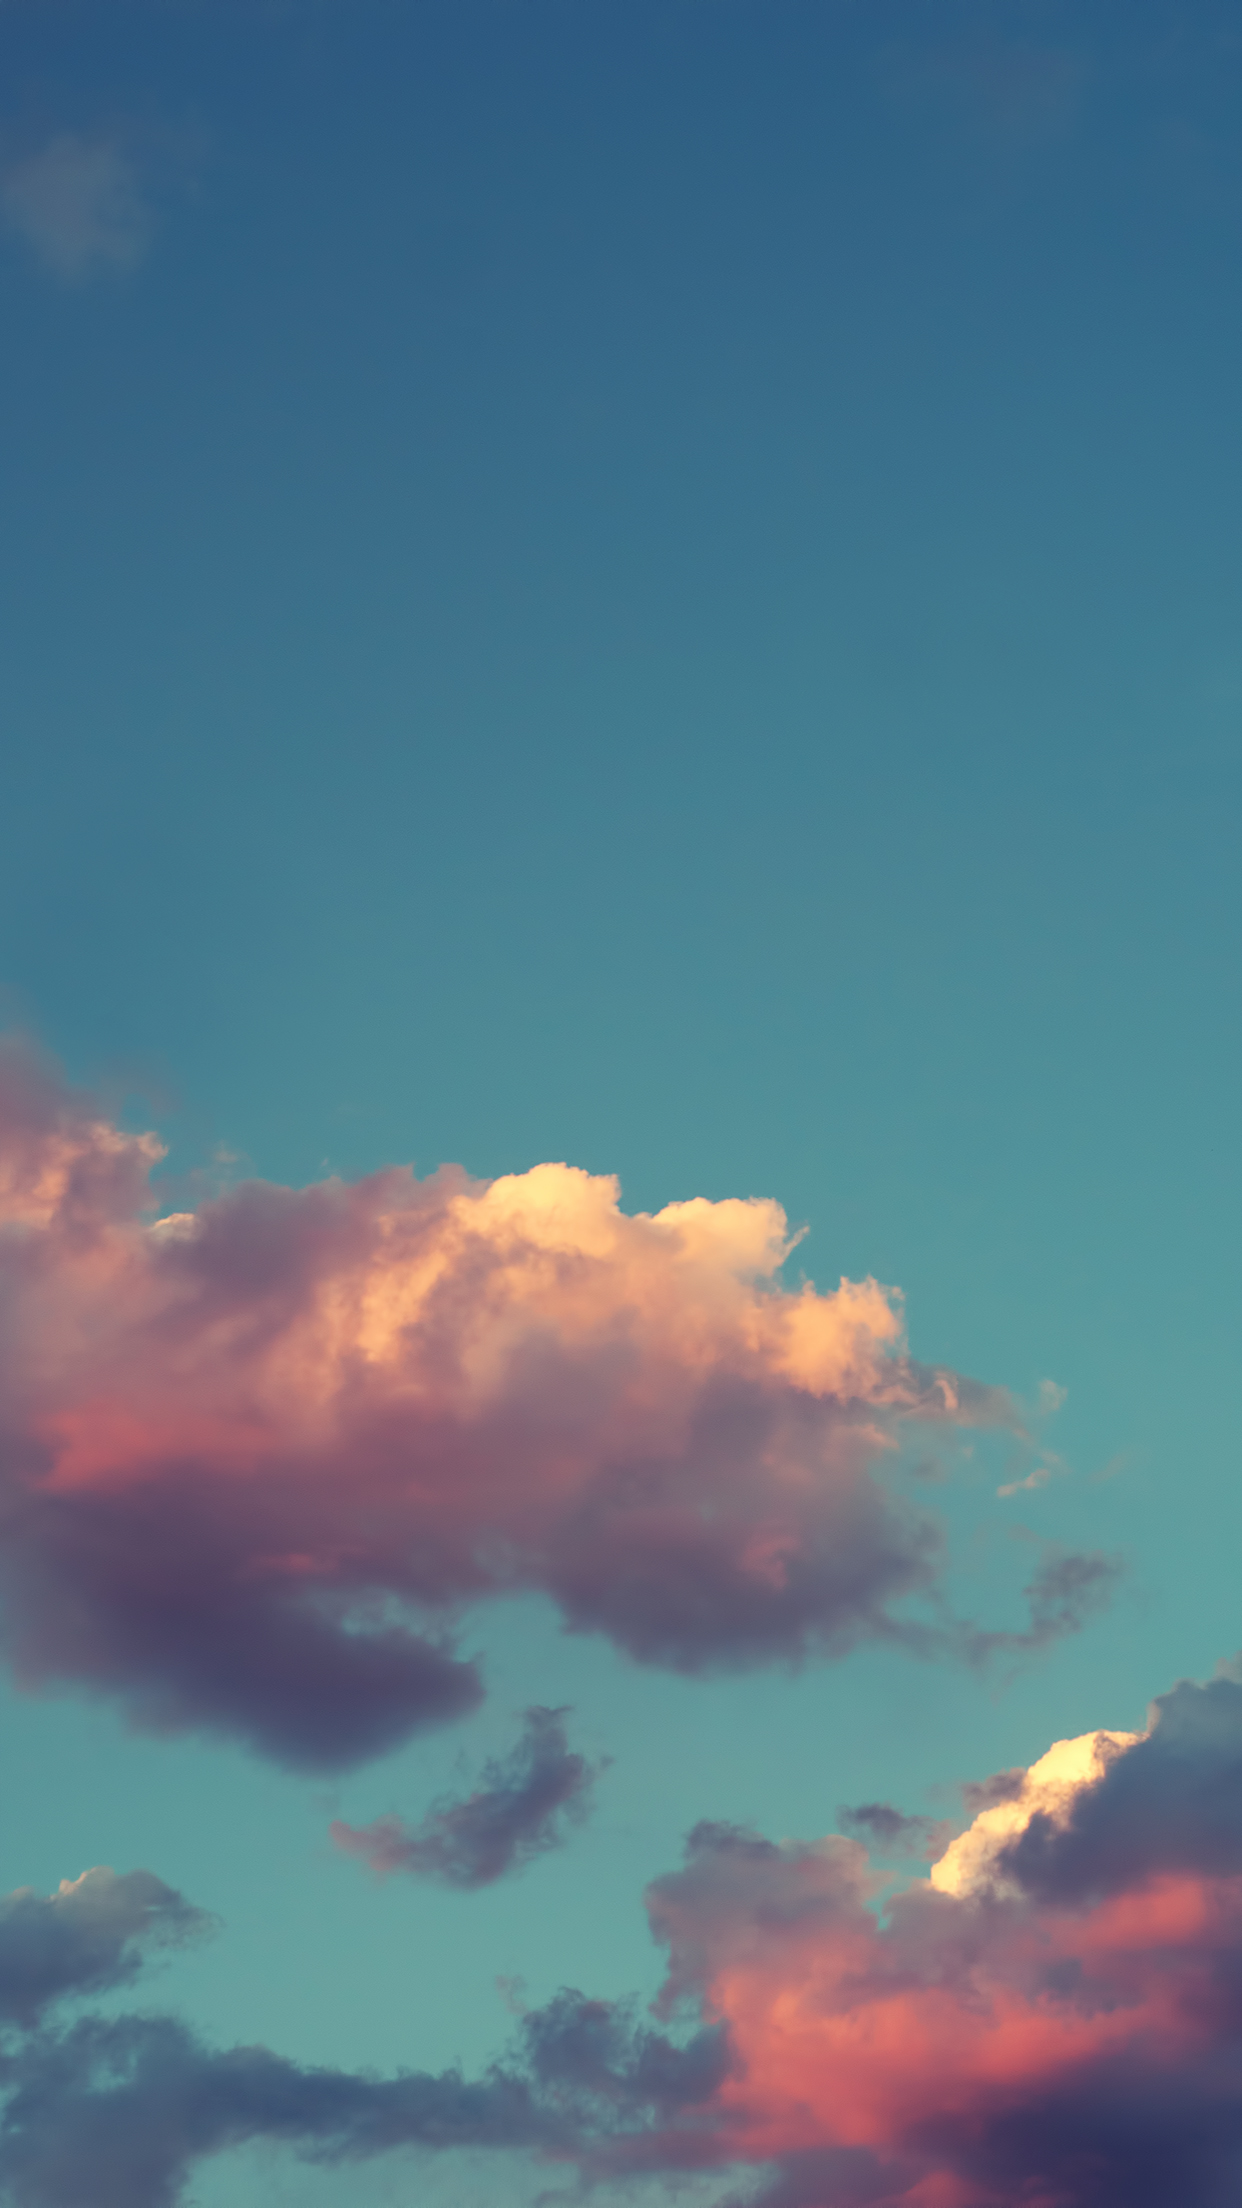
[{"x1": 612, "y1": 1678, "x2": 1242, "y2": 2208}]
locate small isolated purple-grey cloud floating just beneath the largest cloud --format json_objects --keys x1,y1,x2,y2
[{"x1": 331, "y1": 1709, "x2": 603, "y2": 1888}]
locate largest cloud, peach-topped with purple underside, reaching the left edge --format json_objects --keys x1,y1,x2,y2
[{"x1": 0, "y1": 1047, "x2": 1078, "y2": 1769}]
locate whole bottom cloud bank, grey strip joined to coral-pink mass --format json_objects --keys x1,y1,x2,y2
[{"x1": 0, "y1": 1676, "x2": 1242, "y2": 2208}]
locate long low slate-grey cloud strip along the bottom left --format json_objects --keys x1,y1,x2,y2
[{"x1": 0, "y1": 1992, "x2": 716, "y2": 2208}]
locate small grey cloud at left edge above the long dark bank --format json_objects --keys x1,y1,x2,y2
[{"x1": 0, "y1": 1868, "x2": 212, "y2": 2025}]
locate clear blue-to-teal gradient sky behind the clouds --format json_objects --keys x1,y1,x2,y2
[{"x1": 0, "y1": 0, "x2": 1242, "y2": 2208}]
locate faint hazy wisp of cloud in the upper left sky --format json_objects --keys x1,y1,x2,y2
[{"x1": 0, "y1": 130, "x2": 152, "y2": 283}]
